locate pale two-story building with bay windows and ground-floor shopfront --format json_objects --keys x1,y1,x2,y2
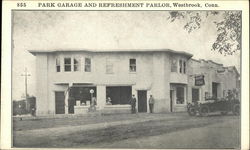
[{"x1": 29, "y1": 49, "x2": 192, "y2": 115}]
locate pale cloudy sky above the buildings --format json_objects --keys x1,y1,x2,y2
[{"x1": 12, "y1": 11, "x2": 240, "y2": 100}]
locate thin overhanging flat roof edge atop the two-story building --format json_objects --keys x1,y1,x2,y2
[{"x1": 28, "y1": 49, "x2": 193, "y2": 57}]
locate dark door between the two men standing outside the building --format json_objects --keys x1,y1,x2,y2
[{"x1": 138, "y1": 90, "x2": 147, "y2": 112}]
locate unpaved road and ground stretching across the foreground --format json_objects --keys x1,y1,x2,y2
[{"x1": 13, "y1": 113, "x2": 240, "y2": 148}]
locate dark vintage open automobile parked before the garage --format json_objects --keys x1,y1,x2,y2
[{"x1": 187, "y1": 98, "x2": 240, "y2": 116}]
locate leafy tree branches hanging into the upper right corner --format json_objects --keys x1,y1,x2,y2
[{"x1": 168, "y1": 11, "x2": 242, "y2": 56}]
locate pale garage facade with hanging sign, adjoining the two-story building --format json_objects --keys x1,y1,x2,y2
[{"x1": 188, "y1": 59, "x2": 240, "y2": 102}]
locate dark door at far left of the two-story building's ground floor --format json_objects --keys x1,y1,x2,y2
[{"x1": 55, "y1": 92, "x2": 65, "y2": 114}]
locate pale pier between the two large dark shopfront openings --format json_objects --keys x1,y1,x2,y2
[{"x1": 96, "y1": 85, "x2": 106, "y2": 109}]
